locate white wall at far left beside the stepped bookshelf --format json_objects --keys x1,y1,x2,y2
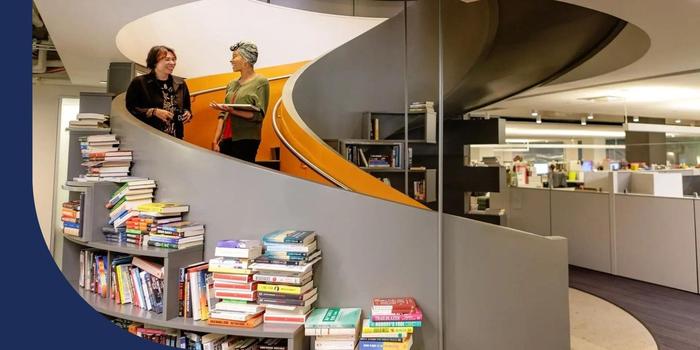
[{"x1": 32, "y1": 83, "x2": 105, "y2": 253}]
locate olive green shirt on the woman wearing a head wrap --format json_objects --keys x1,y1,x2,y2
[{"x1": 219, "y1": 75, "x2": 270, "y2": 141}]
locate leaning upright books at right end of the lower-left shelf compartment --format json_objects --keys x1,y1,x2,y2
[{"x1": 110, "y1": 255, "x2": 165, "y2": 314}]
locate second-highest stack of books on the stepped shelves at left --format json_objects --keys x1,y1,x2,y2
[{"x1": 76, "y1": 134, "x2": 133, "y2": 181}]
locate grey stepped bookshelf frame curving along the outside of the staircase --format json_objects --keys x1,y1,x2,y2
[{"x1": 56, "y1": 94, "x2": 308, "y2": 350}]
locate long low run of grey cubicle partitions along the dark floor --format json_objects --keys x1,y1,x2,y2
[{"x1": 496, "y1": 185, "x2": 700, "y2": 293}]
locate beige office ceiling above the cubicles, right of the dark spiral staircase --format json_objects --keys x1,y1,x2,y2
[{"x1": 485, "y1": 0, "x2": 700, "y2": 123}]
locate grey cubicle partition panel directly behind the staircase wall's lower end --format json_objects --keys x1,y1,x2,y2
[{"x1": 543, "y1": 190, "x2": 612, "y2": 273}]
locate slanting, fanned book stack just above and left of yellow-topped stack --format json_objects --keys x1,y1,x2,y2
[{"x1": 105, "y1": 179, "x2": 156, "y2": 229}]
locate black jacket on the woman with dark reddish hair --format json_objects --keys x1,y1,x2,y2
[{"x1": 126, "y1": 72, "x2": 192, "y2": 139}]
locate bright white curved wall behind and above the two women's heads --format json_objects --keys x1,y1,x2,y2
[{"x1": 116, "y1": 0, "x2": 385, "y2": 77}]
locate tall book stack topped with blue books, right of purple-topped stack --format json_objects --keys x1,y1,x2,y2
[{"x1": 251, "y1": 230, "x2": 321, "y2": 324}]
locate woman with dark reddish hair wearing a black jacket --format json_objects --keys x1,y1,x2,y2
[{"x1": 126, "y1": 45, "x2": 192, "y2": 139}]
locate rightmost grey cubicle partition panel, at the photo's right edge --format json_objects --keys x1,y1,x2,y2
[{"x1": 615, "y1": 194, "x2": 698, "y2": 293}]
